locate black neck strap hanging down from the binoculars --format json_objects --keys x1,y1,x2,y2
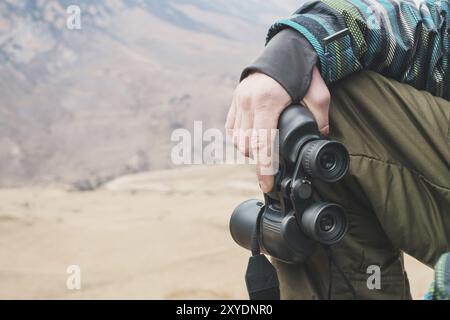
[{"x1": 245, "y1": 207, "x2": 280, "y2": 300}]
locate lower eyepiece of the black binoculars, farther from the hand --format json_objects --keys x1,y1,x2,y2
[{"x1": 300, "y1": 202, "x2": 347, "y2": 245}]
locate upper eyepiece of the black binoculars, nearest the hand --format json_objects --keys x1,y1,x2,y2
[{"x1": 301, "y1": 140, "x2": 350, "y2": 182}]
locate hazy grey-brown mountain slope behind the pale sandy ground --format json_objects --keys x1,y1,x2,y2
[{"x1": 0, "y1": 0, "x2": 299, "y2": 189}]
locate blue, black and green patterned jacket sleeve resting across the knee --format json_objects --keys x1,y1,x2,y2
[{"x1": 267, "y1": 0, "x2": 450, "y2": 97}]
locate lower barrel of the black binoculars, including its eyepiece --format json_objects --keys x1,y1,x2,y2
[{"x1": 230, "y1": 199, "x2": 347, "y2": 263}]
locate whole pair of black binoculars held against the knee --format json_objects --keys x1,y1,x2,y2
[{"x1": 230, "y1": 105, "x2": 349, "y2": 263}]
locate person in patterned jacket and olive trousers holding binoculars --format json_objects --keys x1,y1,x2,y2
[{"x1": 225, "y1": 0, "x2": 450, "y2": 299}]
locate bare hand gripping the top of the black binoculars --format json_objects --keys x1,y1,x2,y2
[{"x1": 225, "y1": 67, "x2": 330, "y2": 193}]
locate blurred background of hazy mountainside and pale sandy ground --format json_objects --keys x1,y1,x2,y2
[{"x1": 0, "y1": 0, "x2": 432, "y2": 299}]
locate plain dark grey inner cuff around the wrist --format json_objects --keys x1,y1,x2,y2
[{"x1": 241, "y1": 28, "x2": 317, "y2": 103}]
